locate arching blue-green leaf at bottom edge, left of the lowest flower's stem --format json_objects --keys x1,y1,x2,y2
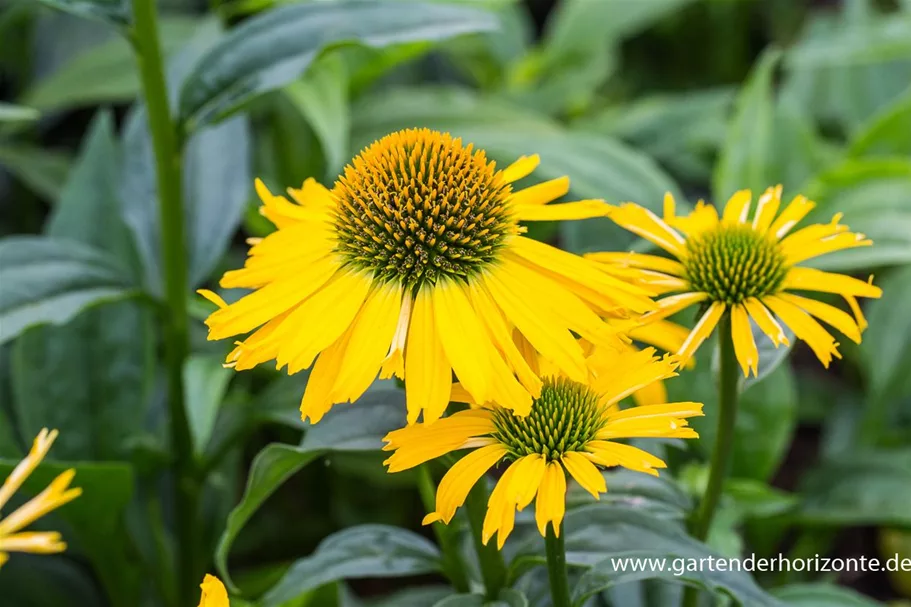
[{"x1": 260, "y1": 525, "x2": 441, "y2": 607}]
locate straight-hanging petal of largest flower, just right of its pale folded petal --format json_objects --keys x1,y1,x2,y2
[{"x1": 405, "y1": 288, "x2": 452, "y2": 424}]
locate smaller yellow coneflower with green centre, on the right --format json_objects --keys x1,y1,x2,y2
[{"x1": 588, "y1": 186, "x2": 882, "y2": 376}]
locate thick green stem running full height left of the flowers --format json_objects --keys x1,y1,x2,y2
[{"x1": 131, "y1": 0, "x2": 202, "y2": 605}]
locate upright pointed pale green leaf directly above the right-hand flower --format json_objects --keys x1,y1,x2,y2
[{"x1": 712, "y1": 49, "x2": 781, "y2": 204}]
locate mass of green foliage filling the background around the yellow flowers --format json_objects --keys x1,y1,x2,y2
[{"x1": 0, "y1": 0, "x2": 911, "y2": 607}]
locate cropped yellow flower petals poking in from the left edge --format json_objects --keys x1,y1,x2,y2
[{"x1": 0, "y1": 428, "x2": 82, "y2": 567}]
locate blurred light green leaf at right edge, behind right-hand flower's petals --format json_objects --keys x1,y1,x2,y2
[{"x1": 803, "y1": 157, "x2": 911, "y2": 271}]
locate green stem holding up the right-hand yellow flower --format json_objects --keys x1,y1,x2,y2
[{"x1": 683, "y1": 313, "x2": 740, "y2": 607}]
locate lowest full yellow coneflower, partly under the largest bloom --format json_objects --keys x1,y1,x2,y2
[{"x1": 384, "y1": 348, "x2": 702, "y2": 548}]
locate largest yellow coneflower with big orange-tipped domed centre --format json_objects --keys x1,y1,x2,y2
[{"x1": 202, "y1": 129, "x2": 654, "y2": 423}]
